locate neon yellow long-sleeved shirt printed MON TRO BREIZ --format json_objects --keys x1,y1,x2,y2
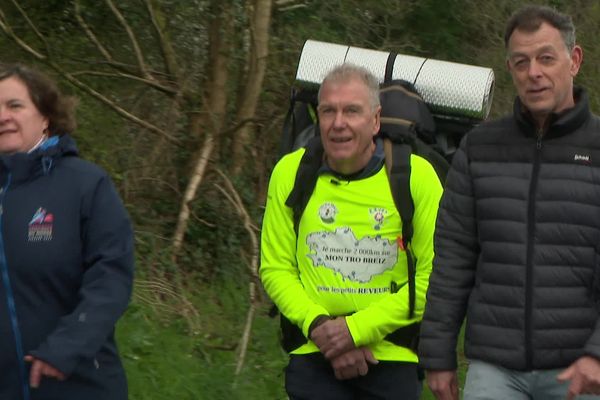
[{"x1": 260, "y1": 145, "x2": 442, "y2": 362}]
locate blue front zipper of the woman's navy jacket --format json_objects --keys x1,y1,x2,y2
[{"x1": 0, "y1": 174, "x2": 30, "y2": 400}]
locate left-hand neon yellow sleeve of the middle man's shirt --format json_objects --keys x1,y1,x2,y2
[{"x1": 260, "y1": 149, "x2": 329, "y2": 337}]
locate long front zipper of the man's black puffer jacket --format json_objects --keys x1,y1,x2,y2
[{"x1": 525, "y1": 134, "x2": 543, "y2": 370}]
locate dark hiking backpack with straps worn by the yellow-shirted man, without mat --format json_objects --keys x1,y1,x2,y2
[{"x1": 280, "y1": 72, "x2": 464, "y2": 352}]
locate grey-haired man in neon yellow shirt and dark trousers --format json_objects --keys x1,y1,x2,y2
[{"x1": 260, "y1": 64, "x2": 442, "y2": 400}]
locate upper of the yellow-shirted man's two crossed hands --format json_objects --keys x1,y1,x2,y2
[{"x1": 310, "y1": 317, "x2": 356, "y2": 361}]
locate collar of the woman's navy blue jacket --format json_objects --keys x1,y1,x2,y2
[{"x1": 0, "y1": 134, "x2": 77, "y2": 184}]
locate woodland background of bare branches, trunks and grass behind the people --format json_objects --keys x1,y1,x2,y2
[{"x1": 0, "y1": 0, "x2": 600, "y2": 400}]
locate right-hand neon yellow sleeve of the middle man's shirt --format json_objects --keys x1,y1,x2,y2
[{"x1": 346, "y1": 155, "x2": 442, "y2": 347}]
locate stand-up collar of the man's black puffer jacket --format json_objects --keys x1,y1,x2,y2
[{"x1": 513, "y1": 87, "x2": 591, "y2": 138}]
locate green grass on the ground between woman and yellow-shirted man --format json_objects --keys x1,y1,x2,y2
[{"x1": 117, "y1": 276, "x2": 465, "y2": 400}]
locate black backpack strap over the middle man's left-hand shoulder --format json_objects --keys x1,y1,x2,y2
[{"x1": 285, "y1": 136, "x2": 324, "y2": 234}]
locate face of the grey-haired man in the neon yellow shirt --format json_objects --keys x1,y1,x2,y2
[{"x1": 317, "y1": 78, "x2": 381, "y2": 174}]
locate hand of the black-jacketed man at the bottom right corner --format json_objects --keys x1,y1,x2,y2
[{"x1": 556, "y1": 356, "x2": 600, "y2": 400}]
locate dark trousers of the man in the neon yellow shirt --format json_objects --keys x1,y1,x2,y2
[{"x1": 285, "y1": 353, "x2": 422, "y2": 400}]
